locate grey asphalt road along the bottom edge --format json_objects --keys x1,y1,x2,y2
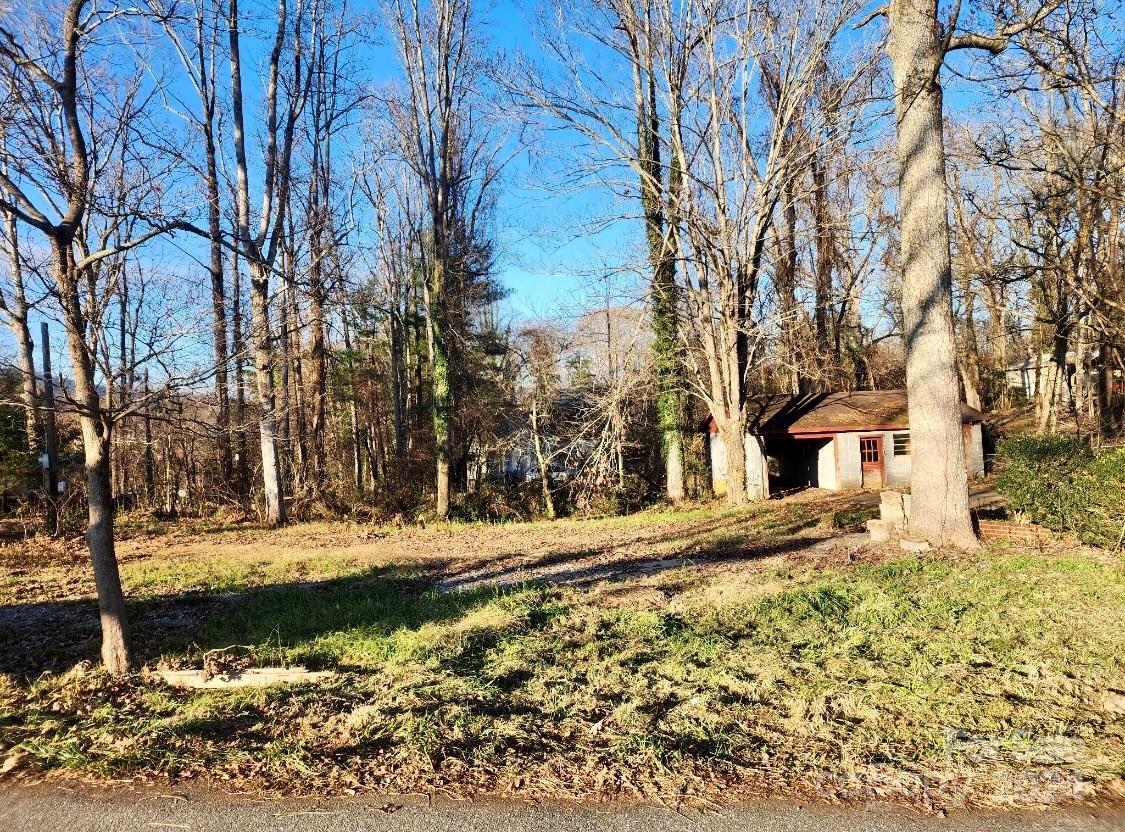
[{"x1": 0, "y1": 787, "x2": 1125, "y2": 832}]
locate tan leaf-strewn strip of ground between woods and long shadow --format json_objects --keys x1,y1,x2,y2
[{"x1": 0, "y1": 491, "x2": 878, "y2": 607}]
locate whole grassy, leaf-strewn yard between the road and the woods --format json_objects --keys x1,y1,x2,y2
[{"x1": 0, "y1": 497, "x2": 1125, "y2": 805}]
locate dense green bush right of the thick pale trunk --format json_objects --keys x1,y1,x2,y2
[{"x1": 996, "y1": 435, "x2": 1125, "y2": 548}]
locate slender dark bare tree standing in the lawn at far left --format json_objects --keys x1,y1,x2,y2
[{"x1": 0, "y1": 0, "x2": 186, "y2": 673}]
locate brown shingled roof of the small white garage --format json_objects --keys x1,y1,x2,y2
[{"x1": 708, "y1": 390, "x2": 984, "y2": 434}]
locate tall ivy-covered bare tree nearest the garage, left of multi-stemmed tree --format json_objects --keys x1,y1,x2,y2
[{"x1": 511, "y1": 0, "x2": 686, "y2": 503}]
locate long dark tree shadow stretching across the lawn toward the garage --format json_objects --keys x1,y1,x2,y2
[{"x1": 0, "y1": 516, "x2": 846, "y2": 680}]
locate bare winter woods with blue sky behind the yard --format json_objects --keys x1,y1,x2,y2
[{"x1": 0, "y1": 0, "x2": 1125, "y2": 663}]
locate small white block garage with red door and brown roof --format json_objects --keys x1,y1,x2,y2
[{"x1": 702, "y1": 390, "x2": 984, "y2": 499}]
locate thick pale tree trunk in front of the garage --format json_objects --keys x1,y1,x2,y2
[{"x1": 888, "y1": 0, "x2": 979, "y2": 548}]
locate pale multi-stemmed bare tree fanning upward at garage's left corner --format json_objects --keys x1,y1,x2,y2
[{"x1": 662, "y1": 2, "x2": 853, "y2": 505}]
